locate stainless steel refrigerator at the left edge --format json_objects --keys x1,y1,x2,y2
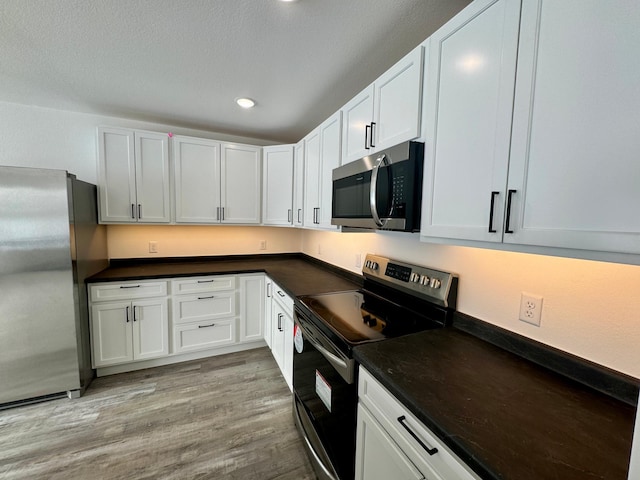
[{"x1": 0, "y1": 166, "x2": 108, "y2": 408}]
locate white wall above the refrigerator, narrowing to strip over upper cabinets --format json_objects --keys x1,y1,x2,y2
[{"x1": 0, "y1": 102, "x2": 272, "y2": 184}]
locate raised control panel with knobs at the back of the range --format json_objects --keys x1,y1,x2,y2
[{"x1": 362, "y1": 254, "x2": 458, "y2": 308}]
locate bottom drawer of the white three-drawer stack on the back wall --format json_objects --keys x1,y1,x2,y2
[{"x1": 173, "y1": 318, "x2": 236, "y2": 353}]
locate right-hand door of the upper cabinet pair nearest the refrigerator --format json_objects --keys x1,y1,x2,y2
[{"x1": 135, "y1": 132, "x2": 171, "y2": 223}]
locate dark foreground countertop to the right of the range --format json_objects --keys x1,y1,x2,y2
[{"x1": 354, "y1": 327, "x2": 635, "y2": 480}]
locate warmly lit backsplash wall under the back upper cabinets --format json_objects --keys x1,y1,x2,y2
[{"x1": 107, "y1": 225, "x2": 302, "y2": 259}]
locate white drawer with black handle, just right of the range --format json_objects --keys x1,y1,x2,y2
[{"x1": 358, "y1": 368, "x2": 480, "y2": 480}]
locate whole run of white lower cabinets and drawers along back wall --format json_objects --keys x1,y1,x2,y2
[{"x1": 89, "y1": 273, "x2": 268, "y2": 376}]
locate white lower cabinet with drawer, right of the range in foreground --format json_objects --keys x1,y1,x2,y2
[{"x1": 355, "y1": 367, "x2": 480, "y2": 480}]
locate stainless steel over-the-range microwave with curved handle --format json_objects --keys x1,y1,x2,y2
[{"x1": 331, "y1": 142, "x2": 424, "y2": 232}]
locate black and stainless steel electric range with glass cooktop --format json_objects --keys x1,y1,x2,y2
[{"x1": 293, "y1": 255, "x2": 458, "y2": 480}]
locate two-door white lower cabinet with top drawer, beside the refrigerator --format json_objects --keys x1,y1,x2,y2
[{"x1": 90, "y1": 282, "x2": 169, "y2": 368}]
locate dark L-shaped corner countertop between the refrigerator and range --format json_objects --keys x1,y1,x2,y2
[{"x1": 87, "y1": 254, "x2": 362, "y2": 297}]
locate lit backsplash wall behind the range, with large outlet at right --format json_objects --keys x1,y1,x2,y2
[{"x1": 302, "y1": 230, "x2": 640, "y2": 378}]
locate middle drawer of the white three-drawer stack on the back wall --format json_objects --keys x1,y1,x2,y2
[{"x1": 173, "y1": 292, "x2": 236, "y2": 324}]
